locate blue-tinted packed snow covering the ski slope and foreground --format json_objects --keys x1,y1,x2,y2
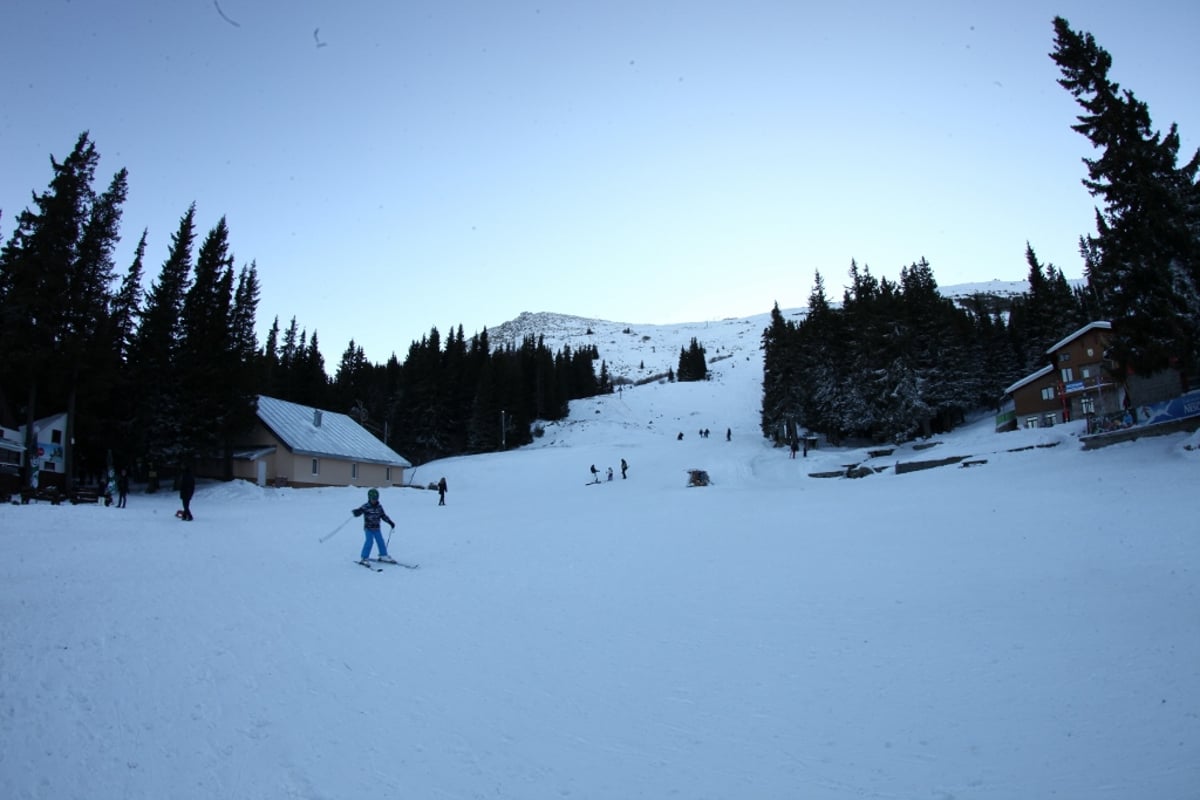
[{"x1": 0, "y1": 317, "x2": 1200, "y2": 800}]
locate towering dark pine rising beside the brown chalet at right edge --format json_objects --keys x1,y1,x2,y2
[{"x1": 1050, "y1": 17, "x2": 1200, "y2": 374}]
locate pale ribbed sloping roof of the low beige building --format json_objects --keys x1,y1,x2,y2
[{"x1": 258, "y1": 395, "x2": 412, "y2": 467}]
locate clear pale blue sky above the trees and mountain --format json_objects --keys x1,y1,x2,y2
[{"x1": 0, "y1": 0, "x2": 1200, "y2": 362}]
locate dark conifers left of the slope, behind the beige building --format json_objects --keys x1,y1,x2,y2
[{"x1": 0, "y1": 132, "x2": 600, "y2": 487}]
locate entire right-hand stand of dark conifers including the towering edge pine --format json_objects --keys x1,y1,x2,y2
[{"x1": 761, "y1": 17, "x2": 1200, "y2": 443}]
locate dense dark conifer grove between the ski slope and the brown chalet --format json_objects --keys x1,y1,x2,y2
[{"x1": 762, "y1": 247, "x2": 1090, "y2": 444}]
